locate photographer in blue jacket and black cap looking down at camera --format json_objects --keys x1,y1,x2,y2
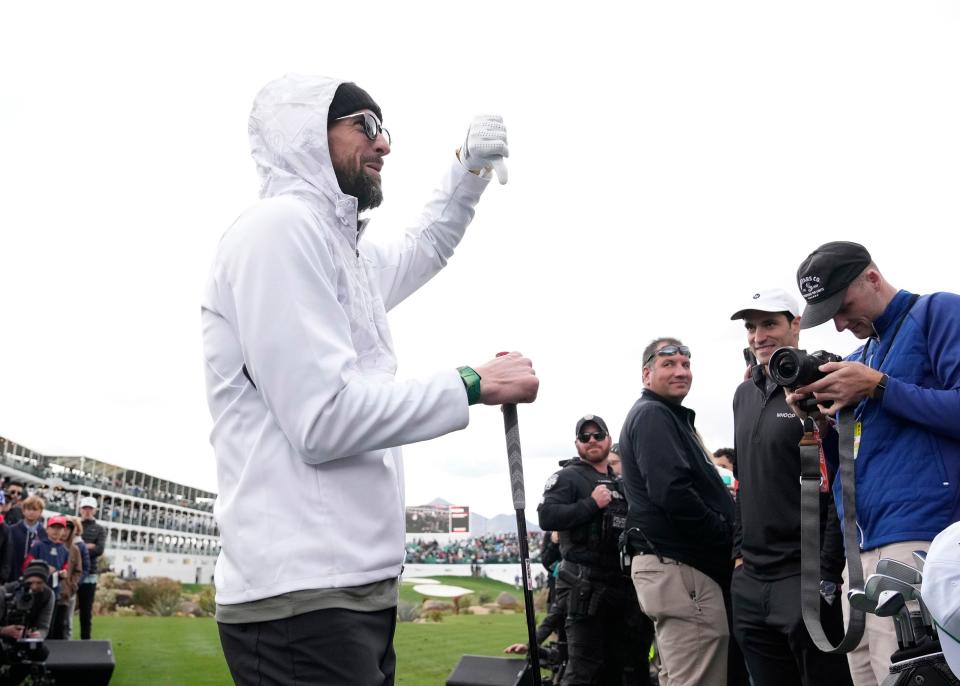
[{"x1": 789, "y1": 242, "x2": 960, "y2": 686}]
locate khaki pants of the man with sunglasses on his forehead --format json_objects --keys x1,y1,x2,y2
[{"x1": 630, "y1": 555, "x2": 729, "y2": 686}]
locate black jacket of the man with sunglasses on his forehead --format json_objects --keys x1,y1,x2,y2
[{"x1": 620, "y1": 389, "x2": 734, "y2": 587}]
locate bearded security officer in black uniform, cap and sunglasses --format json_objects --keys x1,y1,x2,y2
[{"x1": 537, "y1": 415, "x2": 652, "y2": 686}]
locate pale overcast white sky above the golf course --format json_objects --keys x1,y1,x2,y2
[{"x1": 0, "y1": 0, "x2": 960, "y2": 518}]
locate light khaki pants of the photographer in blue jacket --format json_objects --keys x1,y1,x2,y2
[{"x1": 841, "y1": 541, "x2": 930, "y2": 686}]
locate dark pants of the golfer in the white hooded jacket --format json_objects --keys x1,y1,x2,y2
[{"x1": 218, "y1": 608, "x2": 397, "y2": 686}]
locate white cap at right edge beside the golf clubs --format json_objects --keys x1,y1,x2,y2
[{"x1": 920, "y1": 522, "x2": 960, "y2": 674}]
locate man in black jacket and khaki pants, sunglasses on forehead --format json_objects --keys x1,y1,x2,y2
[{"x1": 620, "y1": 338, "x2": 736, "y2": 686}]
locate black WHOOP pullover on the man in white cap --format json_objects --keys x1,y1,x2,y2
[{"x1": 733, "y1": 367, "x2": 844, "y2": 583}]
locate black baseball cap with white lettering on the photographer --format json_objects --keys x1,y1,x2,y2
[{"x1": 797, "y1": 241, "x2": 873, "y2": 329}]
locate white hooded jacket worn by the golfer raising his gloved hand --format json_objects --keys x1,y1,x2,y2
[{"x1": 201, "y1": 76, "x2": 488, "y2": 605}]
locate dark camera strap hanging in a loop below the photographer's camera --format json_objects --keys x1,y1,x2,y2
[{"x1": 800, "y1": 417, "x2": 865, "y2": 653}]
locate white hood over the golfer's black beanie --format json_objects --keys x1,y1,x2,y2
[{"x1": 248, "y1": 74, "x2": 379, "y2": 211}]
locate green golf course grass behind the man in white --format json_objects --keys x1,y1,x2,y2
[{"x1": 91, "y1": 577, "x2": 526, "y2": 686}]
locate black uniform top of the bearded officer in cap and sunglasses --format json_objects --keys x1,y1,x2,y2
[{"x1": 537, "y1": 460, "x2": 627, "y2": 570}]
